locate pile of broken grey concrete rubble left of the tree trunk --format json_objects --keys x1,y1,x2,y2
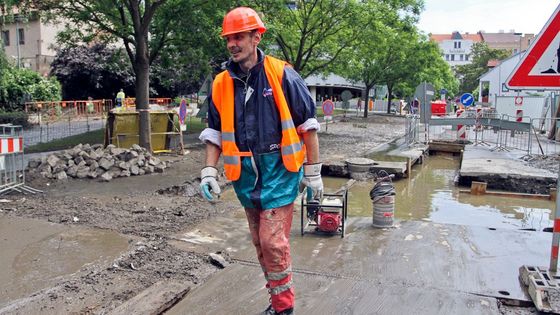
[{"x1": 28, "y1": 144, "x2": 167, "y2": 181}]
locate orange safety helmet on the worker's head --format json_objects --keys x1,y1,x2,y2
[{"x1": 222, "y1": 7, "x2": 266, "y2": 37}]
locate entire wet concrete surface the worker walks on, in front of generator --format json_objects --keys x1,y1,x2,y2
[{"x1": 168, "y1": 207, "x2": 552, "y2": 314}]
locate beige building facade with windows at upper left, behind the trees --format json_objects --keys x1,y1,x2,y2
[{"x1": 0, "y1": 14, "x2": 62, "y2": 75}]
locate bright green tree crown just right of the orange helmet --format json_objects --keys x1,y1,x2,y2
[{"x1": 258, "y1": 0, "x2": 358, "y2": 78}]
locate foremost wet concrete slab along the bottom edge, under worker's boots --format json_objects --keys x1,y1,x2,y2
[{"x1": 166, "y1": 264, "x2": 499, "y2": 315}]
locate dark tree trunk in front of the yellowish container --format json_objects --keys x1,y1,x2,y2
[{"x1": 134, "y1": 36, "x2": 152, "y2": 152}]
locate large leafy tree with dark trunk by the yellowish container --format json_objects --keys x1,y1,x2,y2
[{"x1": 23, "y1": 0, "x2": 241, "y2": 149}]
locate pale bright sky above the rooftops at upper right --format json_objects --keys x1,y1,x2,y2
[{"x1": 418, "y1": 0, "x2": 560, "y2": 34}]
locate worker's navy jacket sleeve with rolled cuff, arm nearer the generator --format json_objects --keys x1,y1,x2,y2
[{"x1": 282, "y1": 67, "x2": 320, "y2": 133}]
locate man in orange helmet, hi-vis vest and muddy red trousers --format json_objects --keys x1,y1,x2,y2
[{"x1": 200, "y1": 7, "x2": 323, "y2": 314}]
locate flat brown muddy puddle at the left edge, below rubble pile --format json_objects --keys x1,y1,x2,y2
[{"x1": 0, "y1": 216, "x2": 128, "y2": 306}]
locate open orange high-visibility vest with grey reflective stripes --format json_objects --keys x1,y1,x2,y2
[{"x1": 212, "y1": 56, "x2": 305, "y2": 181}]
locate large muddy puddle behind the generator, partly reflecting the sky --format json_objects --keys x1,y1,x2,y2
[{"x1": 223, "y1": 155, "x2": 555, "y2": 231}]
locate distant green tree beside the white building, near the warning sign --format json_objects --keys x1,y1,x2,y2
[{"x1": 455, "y1": 43, "x2": 510, "y2": 93}]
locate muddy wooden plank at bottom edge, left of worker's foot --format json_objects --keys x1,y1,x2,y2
[{"x1": 109, "y1": 281, "x2": 191, "y2": 315}]
